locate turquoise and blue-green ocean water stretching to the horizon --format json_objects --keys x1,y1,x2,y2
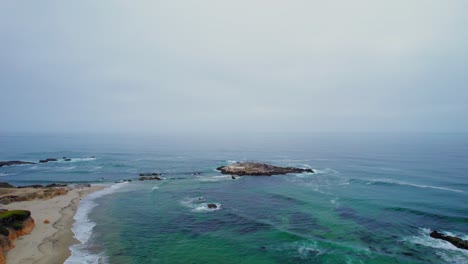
[{"x1": 0, "y1": 134, "x2": 468, "y2": 263}]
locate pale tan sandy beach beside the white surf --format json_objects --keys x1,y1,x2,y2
[{"x1": 2, "y1": 186, "x2": 104, "y2": 264}]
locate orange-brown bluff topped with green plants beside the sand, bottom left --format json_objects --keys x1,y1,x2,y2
[{"x1": 0, "y1": 210, "x2": 34, "y2": 264}]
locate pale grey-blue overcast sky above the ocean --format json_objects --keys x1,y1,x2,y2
[{"x1": 0, "y1": 0, "x2": 468, "y2": 133}]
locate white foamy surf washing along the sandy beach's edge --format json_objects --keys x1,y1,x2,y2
[{"x1": 65, "y1": 182, "x2": 128, "y2": 264}]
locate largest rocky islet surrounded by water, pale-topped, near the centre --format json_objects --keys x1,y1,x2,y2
[{"x1": 217, "y1": 162, "x2": 314, "y2": 176}]
